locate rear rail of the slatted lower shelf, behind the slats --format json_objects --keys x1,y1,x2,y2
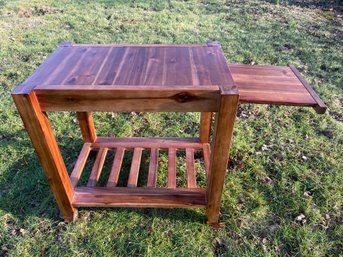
[{"x1": 92, "y1": 137, "x2": 203, "y2": 149}]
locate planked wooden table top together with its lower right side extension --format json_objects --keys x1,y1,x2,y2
[{"x1": 12, "y1": 42, "x2": 326, "y2": 113}]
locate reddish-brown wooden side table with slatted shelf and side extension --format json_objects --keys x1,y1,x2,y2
[{"x1": 12, "y1": 42, "x2": 326, "y2": 224}]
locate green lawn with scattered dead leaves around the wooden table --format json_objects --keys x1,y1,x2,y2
[{"x1": 0, "y1": 0, "x2": 343, "y2": 256}]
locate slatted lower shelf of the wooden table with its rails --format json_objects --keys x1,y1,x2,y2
[{"x1": 70, "y1": 138, "x2": 210, "y2": 208}]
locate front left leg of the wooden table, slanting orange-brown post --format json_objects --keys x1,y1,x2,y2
[{"x1": 12, "y1": 92, "x2": 77, "y2": 221}]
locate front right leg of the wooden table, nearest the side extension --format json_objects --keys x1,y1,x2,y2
[{"x1": 207, "y1": 88, "x2": 238, "y2": 225}]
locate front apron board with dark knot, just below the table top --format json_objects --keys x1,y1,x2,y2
[{"x1": 35, "y1": 86, "x2": 219, "y2": 112}]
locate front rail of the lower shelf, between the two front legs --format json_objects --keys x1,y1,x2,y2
[{"x1": 73, "y1": 187, "x2": 206, "y2": 208}]
